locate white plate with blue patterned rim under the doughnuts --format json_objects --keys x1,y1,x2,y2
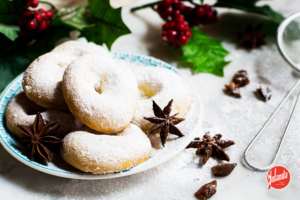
[{"x1": 0, "y1": 52, "x2": 203, "y2": 179}]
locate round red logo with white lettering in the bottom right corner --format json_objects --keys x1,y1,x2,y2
[{"x1": 267, "y1": 166, "x2": 291, "y2": 190}]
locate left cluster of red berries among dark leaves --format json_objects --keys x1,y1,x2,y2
[{"x1": 19, "y1": 9, "x2": 53, "y2": 36}]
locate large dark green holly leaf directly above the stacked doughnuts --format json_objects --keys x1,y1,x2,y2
[{"x1": 82, "y1": 0, "x2": 131, "y2": 49}]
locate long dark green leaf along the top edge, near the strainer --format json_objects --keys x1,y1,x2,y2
[{"x1": 214, "y1": 0, "x2": 284, "y2": 24}]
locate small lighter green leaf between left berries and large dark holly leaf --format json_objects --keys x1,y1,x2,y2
[{"x1": 62, "y1": 3, "x2": 89, "y2": 31}]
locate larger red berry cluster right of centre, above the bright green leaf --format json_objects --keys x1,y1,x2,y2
[{"x1": 157, "y1": 0, "x2": 218, "y2": 46}]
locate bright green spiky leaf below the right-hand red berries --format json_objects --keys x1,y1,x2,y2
[{"x1": 181, "y1": 28, "x2": 229, "y2": 77}]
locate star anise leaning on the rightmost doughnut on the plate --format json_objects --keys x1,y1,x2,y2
[{"x1": 144, "y1": 99, "x2": 184, "y2": 146}]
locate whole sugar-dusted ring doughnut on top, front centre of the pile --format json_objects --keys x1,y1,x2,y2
[{"x1": 63, "y1": 54, "x2": 138, "y2": 134}]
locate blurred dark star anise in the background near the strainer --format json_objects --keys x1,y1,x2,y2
[{"x1": 237, "y1": 24, "x2": 267, "y2": 49}]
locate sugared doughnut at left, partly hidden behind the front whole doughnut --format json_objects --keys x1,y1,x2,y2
[{"x1": 22, "y1": 52, "x2": 77, "y2": 110}]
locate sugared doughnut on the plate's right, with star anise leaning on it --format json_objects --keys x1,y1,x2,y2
[{"x1": 132, "y1": 67, "x2": 193, "y2": 132}]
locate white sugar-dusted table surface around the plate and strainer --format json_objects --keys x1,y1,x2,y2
[{"x1": 0, "y1": 0, "x2": 300, "y2": 200}]
